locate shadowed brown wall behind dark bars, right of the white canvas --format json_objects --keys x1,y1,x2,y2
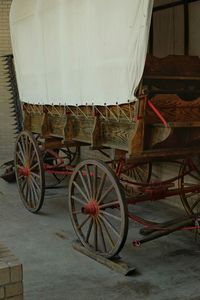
[{"x1": 153, "y1": 0, "x2": 200, "y2": 57}]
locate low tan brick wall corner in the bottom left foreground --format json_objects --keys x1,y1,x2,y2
[{"x1": 0, "y1": 244, "x2": 23, "y2": 300}]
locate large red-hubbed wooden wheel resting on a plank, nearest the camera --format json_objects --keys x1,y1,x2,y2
[{"x1": 69, "y1": 160, "x2": 128, "y2": 258}]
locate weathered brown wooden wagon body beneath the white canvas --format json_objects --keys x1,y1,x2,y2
[{"x1": 21, "y1": 56, "x2": 200, "y2": 161}]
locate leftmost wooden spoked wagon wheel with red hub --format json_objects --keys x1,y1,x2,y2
[{"x1": 15, "y1": 131, "x2": 45, "y2": 213}]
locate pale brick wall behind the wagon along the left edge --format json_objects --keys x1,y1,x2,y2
[{"x1": 0, "y1": 0, "x2": 14, "y2": 164}]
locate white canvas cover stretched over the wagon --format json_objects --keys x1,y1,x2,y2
[{"x1": 10, "y1": 0, "x2": 153, "y2": 105}]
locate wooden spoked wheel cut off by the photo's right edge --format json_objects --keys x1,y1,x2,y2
[{"x1": 178, "y1": 156, "x2": 200, "y2": 214}]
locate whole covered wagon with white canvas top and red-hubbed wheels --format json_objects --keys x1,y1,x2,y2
[{"x1": 6, "y1": 0, "x2": 200, "y2": 257}]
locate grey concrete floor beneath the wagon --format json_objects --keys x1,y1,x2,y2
[{"x1": 0, "y1": 175, "x2": 200, "y2": 300}]
